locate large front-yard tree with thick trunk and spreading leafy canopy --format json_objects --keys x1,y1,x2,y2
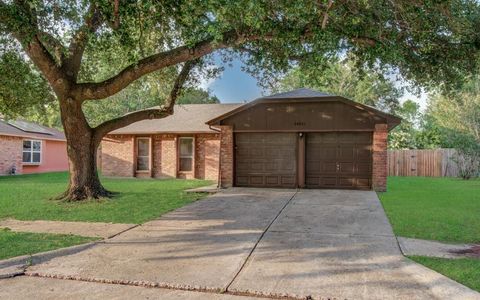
[{"x1": 0, "y1": 0, "x2": 480, "y2": 200}]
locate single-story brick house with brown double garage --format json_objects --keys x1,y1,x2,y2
[{"x1": 101, "y1": 89, "x2": 400, "y2": 191}]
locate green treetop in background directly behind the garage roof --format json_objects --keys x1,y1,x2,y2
[{"x1": 276, "y1": 61, "x2": 403, "y2": 112}]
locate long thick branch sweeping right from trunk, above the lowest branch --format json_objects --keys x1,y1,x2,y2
[{"x1": 74, "y1": 30, "x2": 251, "y2": 100}]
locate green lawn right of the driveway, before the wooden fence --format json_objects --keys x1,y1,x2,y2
[{"x1": 379, "y1": 177, "x2": 480, "y2": 243}]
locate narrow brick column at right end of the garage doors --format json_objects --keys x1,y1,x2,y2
[{"x1": 372, "y1": 124, "x2": 388, "y2": 192}]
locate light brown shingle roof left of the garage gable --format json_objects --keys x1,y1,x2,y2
[{"x1": 110, "y1": 103, "x2": 243, "y2": 134}]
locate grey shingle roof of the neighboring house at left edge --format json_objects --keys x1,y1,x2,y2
[{"x1": 0, "y1": 119, "x2": 65, "y2": 141}]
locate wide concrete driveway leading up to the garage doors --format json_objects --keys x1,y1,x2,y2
[{"x1": 0, "y1": 189, "x2": 480, "y2": 299}]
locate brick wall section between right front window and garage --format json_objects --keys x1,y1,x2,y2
[{"x1": 195, "y1": 134, "x2": 220, "y2": 181}]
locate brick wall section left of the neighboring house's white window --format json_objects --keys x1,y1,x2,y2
[{"x1": 0, "y1": 135, "x2": 23, "y2": 175}]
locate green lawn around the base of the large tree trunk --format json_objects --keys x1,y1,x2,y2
[{"x1": 0, "y1": 172, "x2": 211, "y2": 223}]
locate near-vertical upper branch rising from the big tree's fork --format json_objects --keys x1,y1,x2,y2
[{"x1": 64, "y1": 4, "x2": 103, "y2": 82}]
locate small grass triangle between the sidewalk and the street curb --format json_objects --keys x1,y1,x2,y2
[{"x1": 0, "y1": 230, "x2": 97, "y2": 259}]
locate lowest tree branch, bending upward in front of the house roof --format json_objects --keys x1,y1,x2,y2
[{"x1": 93, "y1": 60, "x2": 197, "y2": 143}]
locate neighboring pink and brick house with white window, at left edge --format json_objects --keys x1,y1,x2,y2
[{"x1": 0, "y1": 119, "x2": 68, "y2": 175}]
